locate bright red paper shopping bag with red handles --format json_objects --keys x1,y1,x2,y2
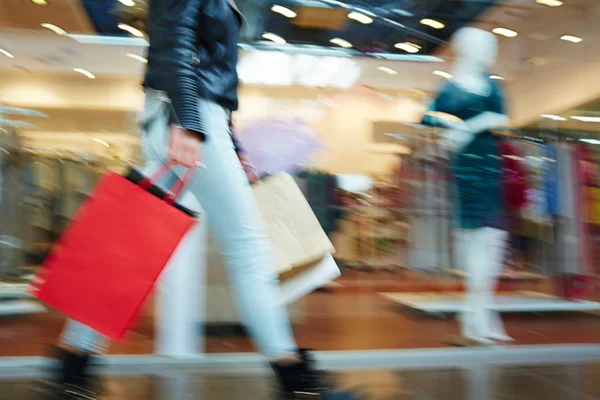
[{"x1": 31, "y1": 164, "x2": 196, "y2": 340}]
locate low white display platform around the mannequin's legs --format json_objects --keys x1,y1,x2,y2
[{"x1": 379, "y1": 291, "x2": 600, "y2": 313}]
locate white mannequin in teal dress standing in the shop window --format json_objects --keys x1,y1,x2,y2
[{"x1": 423, "y1": 28, "x2": 512, "y2": 345}]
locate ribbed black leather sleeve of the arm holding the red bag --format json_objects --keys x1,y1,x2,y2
[{"x1": 162, "y1": 0, "x2": 206, "y2": 138}]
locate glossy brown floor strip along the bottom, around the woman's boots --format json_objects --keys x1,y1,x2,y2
[{"x1": 0, "y1": 364, "x2": 600, "y2": 400}]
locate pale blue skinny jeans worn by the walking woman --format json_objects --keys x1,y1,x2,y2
[{"x1": 61, "y1": 90, "x2": 297, "y2": 357}]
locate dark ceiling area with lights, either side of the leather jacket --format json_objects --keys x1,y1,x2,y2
[{"x1": 82, "y1": 0, "x2": 499, "y2": 54}]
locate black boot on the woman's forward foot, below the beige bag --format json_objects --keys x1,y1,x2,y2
[{"x1": 271, "y1": 349, "x2": 360, "y2": 400}]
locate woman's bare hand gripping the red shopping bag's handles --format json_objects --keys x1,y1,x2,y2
[{"x1": 168, "y1": 125, "x2": 204, "y2": 168}]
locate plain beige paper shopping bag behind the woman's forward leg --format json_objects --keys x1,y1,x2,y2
[{"x1": 254, "y1": 173, "x2": 335, "y2": 274}]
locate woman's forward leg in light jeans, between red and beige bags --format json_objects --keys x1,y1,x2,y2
[{"x1": 183, "y1": 101, "x2": 297, "y2": 359}]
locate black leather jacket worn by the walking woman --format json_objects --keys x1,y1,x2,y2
[{"x1": 144, "y1": 0, "x2": 242, "y2": 139}]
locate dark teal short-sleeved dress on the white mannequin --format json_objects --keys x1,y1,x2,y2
[{"x1": 422, "y1": 78, "x2": 507, "y2": 229}]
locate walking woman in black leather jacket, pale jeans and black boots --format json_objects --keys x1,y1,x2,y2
[{"x1": 34, "y1": 0, "x2": 355, "y2": 399}]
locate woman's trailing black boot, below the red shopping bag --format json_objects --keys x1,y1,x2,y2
[{"x1": 34, "y1": 348, "x2": 96, "y2": 400}]
